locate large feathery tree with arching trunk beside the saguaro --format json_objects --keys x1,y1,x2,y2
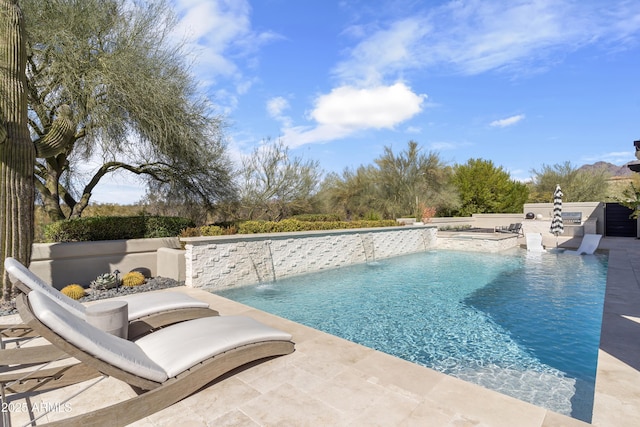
[{"x1": 20, "y1": 0, "x2": 234, "y2": 220}]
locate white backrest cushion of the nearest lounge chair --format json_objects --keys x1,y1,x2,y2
[{"x1": 29, "y1": 292, "x2": 168, "y2": 383}]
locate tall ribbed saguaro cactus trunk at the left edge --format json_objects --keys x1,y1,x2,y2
[{"x1": 0, "y1": 0, "x2": 35, "y2": 301}]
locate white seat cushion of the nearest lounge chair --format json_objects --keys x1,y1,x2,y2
[{"x1": 136, "y1": 316, "x2": 291, "y2": 377}]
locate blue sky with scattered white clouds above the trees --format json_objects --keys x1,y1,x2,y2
[{"x1": 93, "y1": 0, "x2": 640, "y2": 203}]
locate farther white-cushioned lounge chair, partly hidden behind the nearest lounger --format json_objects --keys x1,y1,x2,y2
[{"x1": 3, "y1": 257, "x2": 218, "y2": 339}]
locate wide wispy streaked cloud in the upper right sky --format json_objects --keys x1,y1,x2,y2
[{"x1": 334, "y1": 0, "x2": 640, "y2": 84}]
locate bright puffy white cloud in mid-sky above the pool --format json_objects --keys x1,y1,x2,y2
[{"x1": 283, "y1": 83, "x2": 427, "y2": 147}]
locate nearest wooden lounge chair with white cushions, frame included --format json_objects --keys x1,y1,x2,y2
[{"x1": 10, "y1": 291, "x2": 294, "y2": 426}]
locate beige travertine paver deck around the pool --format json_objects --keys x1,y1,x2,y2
[{"x1": 1, "y1": 238, "x2": 640, "y2": 427}]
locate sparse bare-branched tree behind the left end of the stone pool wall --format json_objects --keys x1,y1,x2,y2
[{"x1": 239, "y1": 140, "x2": 322, "y2": 221}]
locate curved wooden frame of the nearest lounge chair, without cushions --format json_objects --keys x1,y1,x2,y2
[{"x1": 16, "y1": 294, "x2": 294, "y2": 426}]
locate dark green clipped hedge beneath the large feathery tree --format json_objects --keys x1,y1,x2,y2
[{"x1": 44, "y1": 215, "x2": 195, "y2": 242}]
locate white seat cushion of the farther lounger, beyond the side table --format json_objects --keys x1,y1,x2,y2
[{"x1": 114, "y1": 292, "x2": 209, "y2": 321}]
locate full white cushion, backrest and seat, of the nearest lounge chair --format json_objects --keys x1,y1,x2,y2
[{"x1": 28, "y1": 292, "x2": 291, "y2": 383}]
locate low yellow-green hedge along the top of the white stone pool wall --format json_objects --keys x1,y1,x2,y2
[{"x1": 238, "y1": 219, "x2": 398, "y2": 234}]
